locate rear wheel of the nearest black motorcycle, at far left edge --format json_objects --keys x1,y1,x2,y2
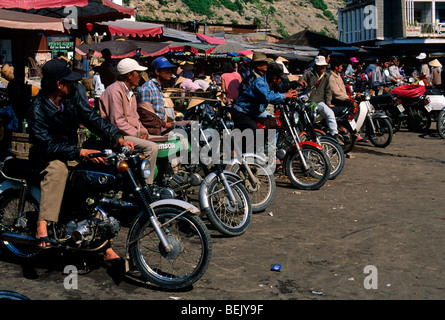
[{"x1": 0, "y1": 190, "x2": 41, "y2": 259}]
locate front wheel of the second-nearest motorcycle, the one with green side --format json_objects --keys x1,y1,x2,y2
[{"x1": 206, "y1": 175, "x2": 252, "y2": 237}]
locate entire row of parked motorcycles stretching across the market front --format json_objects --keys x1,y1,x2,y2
[{"x1": 0, "y1": 73, "x2": 445, "y2": 289}]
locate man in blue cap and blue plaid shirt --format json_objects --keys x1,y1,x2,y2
[{"x1": 137, "y1": 57, "x2": 177, "y2": 125}]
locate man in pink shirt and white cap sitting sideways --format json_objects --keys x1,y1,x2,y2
[{"x1": 100, "y1": 58, "x2": 158, "y2": 184}]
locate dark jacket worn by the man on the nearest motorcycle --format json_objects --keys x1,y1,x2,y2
[{"x1": 29, "y1": 84, "x2": 123, "y2": 166}]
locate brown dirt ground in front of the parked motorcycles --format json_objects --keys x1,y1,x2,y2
[{"x1": 0, "y1": 123, "x2": 445, "y2": 302}]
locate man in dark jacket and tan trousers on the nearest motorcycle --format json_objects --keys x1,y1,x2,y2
[{"x1": 29, "y1": 59, "x2": 134, "y2": 262}]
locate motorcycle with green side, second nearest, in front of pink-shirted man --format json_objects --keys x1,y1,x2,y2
[{"x1": 154, "y1": 101, "x2": 252, "y2": 236}]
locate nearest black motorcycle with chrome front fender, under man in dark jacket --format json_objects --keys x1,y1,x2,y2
[{"x1": 0, "y1": 147, "x2": 212, "y2": 289}]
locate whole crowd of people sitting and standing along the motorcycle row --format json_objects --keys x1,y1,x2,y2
[{"x1": 1, "y1": 50, "x2": 444, "y2": 261}]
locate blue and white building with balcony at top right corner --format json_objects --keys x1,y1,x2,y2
[{"x1": 338, "y1": 0, "x2": 445, "y2": 46}]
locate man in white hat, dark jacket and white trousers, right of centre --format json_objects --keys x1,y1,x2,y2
[{"x1": 303, "y1": 56, "x2": 344, "y2": 145}]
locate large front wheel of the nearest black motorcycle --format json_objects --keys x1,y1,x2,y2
[{"x1": 129, "y1": 206, "x2": 212, "y2": 289}]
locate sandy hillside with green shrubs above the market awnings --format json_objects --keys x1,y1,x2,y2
[{"x1": 127, "y1": 0, "x2": 345, "y2": 38}]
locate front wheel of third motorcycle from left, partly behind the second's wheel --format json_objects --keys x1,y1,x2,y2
[{"x1": 230, "y1": 158, "x2": 277, "y2": 213}]
